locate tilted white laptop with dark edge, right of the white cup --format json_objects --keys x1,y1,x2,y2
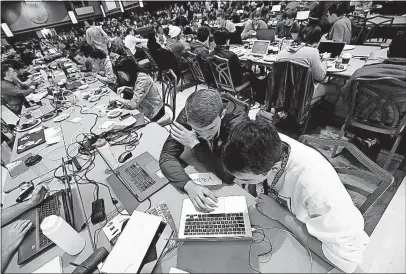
[{"x1": 100, "y1": 211, "x2": 173, "y2": 273}]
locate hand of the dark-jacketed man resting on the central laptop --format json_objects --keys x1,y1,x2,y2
[{"x1": 184, "y1": 181, "x2": 218, "y2": 213}]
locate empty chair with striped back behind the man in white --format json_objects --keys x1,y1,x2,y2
[{"x1": 299, "y1": 135, "x2": 394, "y2": 215}]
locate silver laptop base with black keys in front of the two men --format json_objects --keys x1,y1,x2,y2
[{"x1": 178, "y1": 196, "x2": 252, "y2": 241}]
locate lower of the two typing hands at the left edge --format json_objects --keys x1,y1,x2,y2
[{"x1": 1, "y1": 220, "x2": 32, "y2": 254}]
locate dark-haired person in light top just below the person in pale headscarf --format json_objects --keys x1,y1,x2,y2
[{"x1": 90, "y1": 49, "x2": 117, "y2": 86}]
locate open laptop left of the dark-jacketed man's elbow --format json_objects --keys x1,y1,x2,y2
[{"x1": 102, "y1": 152, "x2": 169, "y2": 202}]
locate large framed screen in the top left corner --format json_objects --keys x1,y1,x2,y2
[{"x1": 1, "y1": 1, "x2": 70, "y2": 33}]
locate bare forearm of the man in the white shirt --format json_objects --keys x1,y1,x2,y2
[{"x1": 278, "y1": 210, "x2": 334, "y2": 266}]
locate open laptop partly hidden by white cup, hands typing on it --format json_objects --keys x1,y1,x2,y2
[{"x1": 17, "y1": 159, "x2": 74, "y2": 265}]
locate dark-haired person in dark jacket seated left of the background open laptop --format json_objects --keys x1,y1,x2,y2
[{"x1": 210, "y1": 28, "x2": 252, "y2": 86}]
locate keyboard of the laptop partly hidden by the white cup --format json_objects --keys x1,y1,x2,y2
[{"x1": 35, "y1": 194, "x2": 59, "y2": 250}]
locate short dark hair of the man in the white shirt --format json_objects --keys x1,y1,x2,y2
[{"x1": 222, "y1": 120, "x2": 282, "y2": 175}]
